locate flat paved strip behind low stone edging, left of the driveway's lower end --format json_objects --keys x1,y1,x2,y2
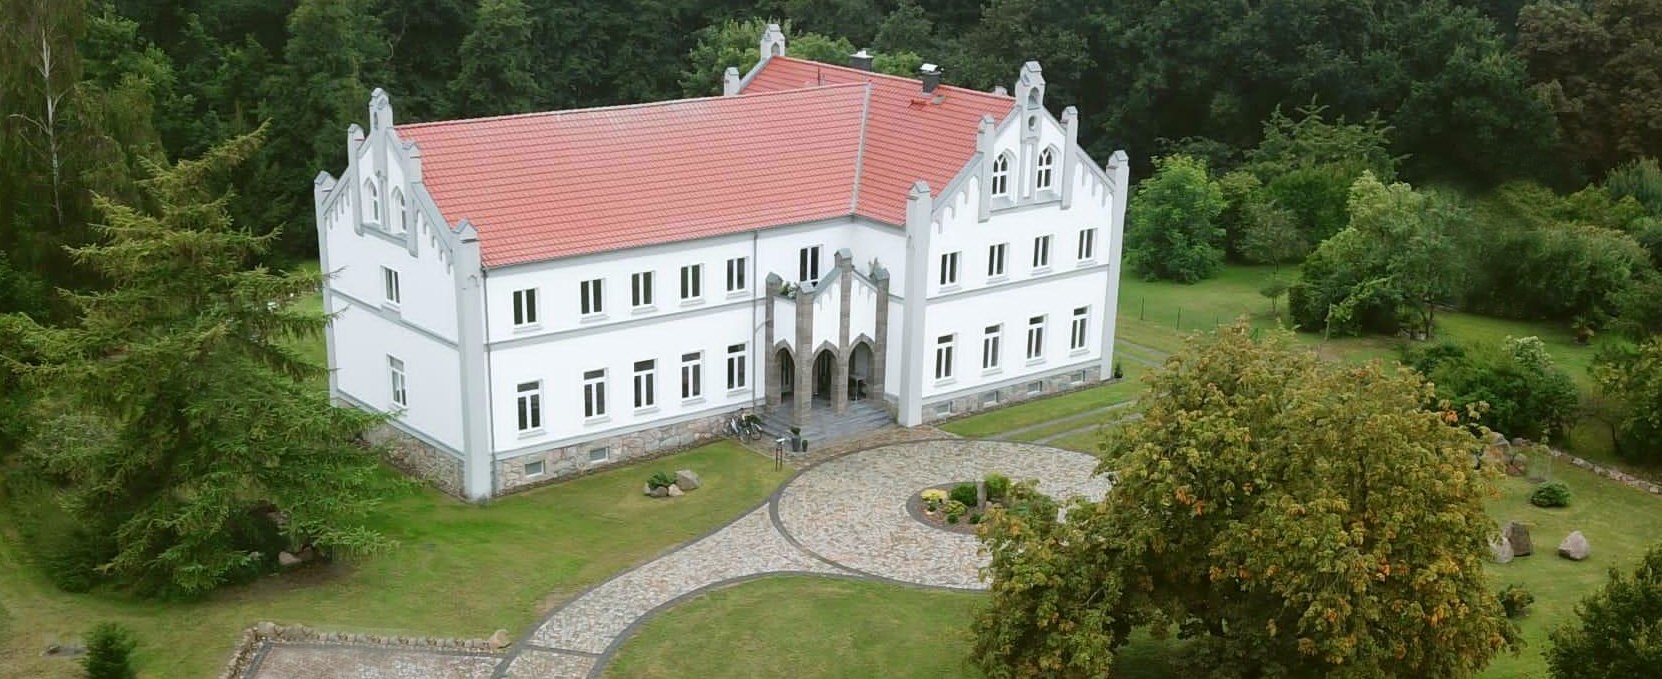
[{"x1": 249, "y1": 644, "x2": 502, "y2": 679}]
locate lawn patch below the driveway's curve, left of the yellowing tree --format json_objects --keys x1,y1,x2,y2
[{"x1": 605, "y1": 576, "x2": 984, "y2": 679}]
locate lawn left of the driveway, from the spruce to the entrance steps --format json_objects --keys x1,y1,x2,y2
[{"x1": 0, "y1": 442, "x2": 789, "y2": 677}]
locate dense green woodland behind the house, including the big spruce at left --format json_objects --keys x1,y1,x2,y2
[{"x1": 0, "y1": 0, "x2": 1662, "y2": 617}]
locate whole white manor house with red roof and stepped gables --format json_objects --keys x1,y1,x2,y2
[{"x1": 314, "y1": 27, "x2": 1128, "y2": 500}]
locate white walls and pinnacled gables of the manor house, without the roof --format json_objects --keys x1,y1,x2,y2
[{"x1": 316, "y1": 54, "x2": 1128, "y2": 500}]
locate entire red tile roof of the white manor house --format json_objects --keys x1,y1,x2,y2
[{"x1": 397, "y1": 56, "x2": 1012, "y2": 267}]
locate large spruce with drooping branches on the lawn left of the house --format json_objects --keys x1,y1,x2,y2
[{"x1": 0, "y1": 133, "x2": 384, "y2": 594}]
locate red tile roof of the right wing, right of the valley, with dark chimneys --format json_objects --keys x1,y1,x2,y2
[{"x1": 745, "y1": 56, "x2": 1015, "y2": 224}]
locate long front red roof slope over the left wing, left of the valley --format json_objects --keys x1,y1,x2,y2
[{"x1": 397, "y1": 85, "x2": 866, "y2": 267}]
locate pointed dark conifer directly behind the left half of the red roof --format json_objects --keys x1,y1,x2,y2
[{"x1": 450, "y1": 0, "x2": 538, "y2": 118}]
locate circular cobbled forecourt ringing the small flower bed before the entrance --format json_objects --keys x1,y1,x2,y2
[{"x1": 773, "y1": 438, "x2": 1109, "y2": 589}]
